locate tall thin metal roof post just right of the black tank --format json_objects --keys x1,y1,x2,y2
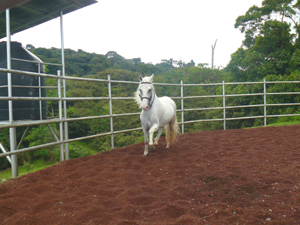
[{"x1": 60, "y1": 11, "x2": 70, "y2": 160}]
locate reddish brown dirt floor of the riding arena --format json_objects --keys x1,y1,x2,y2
[{"x1": 0, "y1": 125, "x2": 300, "y2": 225}]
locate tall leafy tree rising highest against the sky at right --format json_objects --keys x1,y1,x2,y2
[{"x1": 226, "y1": 0, "x2": 299, "y2": 81}]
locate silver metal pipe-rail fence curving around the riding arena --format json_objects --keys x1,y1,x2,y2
[{"x1": 0, "y1": 64, "x2": 300, "y2": 177}]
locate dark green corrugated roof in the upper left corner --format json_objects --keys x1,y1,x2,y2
[{"x1": 0, "y1": 0, "x2": 97, "y2": 39}]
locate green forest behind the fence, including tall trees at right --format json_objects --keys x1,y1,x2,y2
[{"x1": 0, "y1": 0, "x2": 300, "y2": 169}]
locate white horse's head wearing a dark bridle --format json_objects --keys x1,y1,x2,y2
[{"x1": 135, "y1": 74, "x2": 155, "y2": 111}]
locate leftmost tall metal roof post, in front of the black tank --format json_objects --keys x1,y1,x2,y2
[{"x1": 6, "y1": 9, "x2": 18, "y2": 178}]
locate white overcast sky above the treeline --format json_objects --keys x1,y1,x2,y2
[{"x1": 0, "y1": 0, "x2": 262, "y2": 67}]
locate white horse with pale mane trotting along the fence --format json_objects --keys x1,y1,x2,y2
[{"x1": 135, "y1": 74, "x2": 179, "y2": 156}]
